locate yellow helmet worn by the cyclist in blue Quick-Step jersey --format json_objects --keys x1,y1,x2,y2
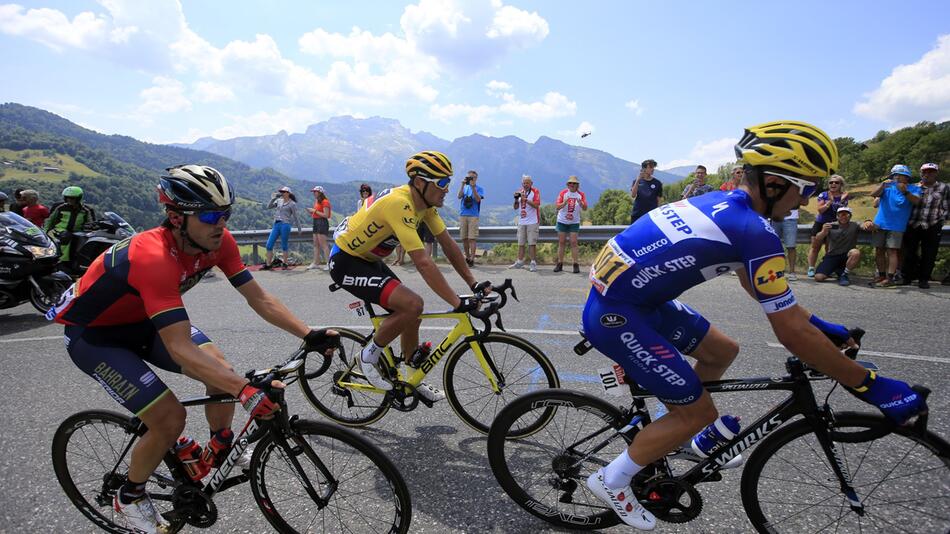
[{"x1": 736, "y1": 121, "x2": 838, "y2": 180}]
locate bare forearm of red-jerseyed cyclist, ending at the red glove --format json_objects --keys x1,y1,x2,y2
[{"x1": 158, "y1": 322, "x2": 247, "y2": 397}]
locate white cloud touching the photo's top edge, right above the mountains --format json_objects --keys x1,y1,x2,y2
[{"x1": 400, "y1": 0, "x2": 550, "y2": 73}]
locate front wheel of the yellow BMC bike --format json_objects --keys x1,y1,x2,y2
[{"x1": 443, "y1": 332, "x2": 560, "y2": 437}]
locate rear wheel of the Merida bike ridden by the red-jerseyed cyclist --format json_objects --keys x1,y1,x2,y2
[{"x1": 52, "y1": 410, "x2": 183, "y2": 533}]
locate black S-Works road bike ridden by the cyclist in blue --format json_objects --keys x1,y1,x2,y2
[{"x1": 488, "y1": 332, "x2": 950, "y2": 533}]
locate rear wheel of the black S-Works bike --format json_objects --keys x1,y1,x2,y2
[{"x1": 488, "y1": 389, "x2": 627, "y2": 530}]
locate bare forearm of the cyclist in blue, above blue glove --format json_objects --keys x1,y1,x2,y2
[{"x1": 768, "y1": 304, "x2": 867, "y2": 387}]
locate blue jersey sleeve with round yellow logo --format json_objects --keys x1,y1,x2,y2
[{"x1": 742, "y1": 215, "x2": 796, "y2": 313}]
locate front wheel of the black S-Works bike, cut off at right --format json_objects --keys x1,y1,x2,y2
[{"x1": 741, "y1": 412, "x2": 950, "y2": 533}]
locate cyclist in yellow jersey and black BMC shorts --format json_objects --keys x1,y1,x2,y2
[{"x1": 330, "y1": 151, "x2": 488, "y2": 401}]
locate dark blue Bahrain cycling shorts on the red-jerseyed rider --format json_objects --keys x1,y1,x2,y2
[{"x1": 64, "y1": 321, "x2": 211, "y2": 416}]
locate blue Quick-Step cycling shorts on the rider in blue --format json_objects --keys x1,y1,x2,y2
[{"x1": 583, "y1": 289, "x2": 709, "y2": 406}]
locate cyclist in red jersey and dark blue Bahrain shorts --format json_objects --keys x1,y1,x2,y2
[{"x1": 50, "y1": 165, "x2": 338, "y2": 533}]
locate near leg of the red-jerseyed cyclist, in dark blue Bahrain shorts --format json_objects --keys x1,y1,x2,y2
[{"x1": 66, "y1": 325, "x2": 185, "y2": 484}]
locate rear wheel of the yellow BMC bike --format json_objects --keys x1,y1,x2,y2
[{"x1": 298, "y1": 328, "x2": 390, "y2": 427}]
